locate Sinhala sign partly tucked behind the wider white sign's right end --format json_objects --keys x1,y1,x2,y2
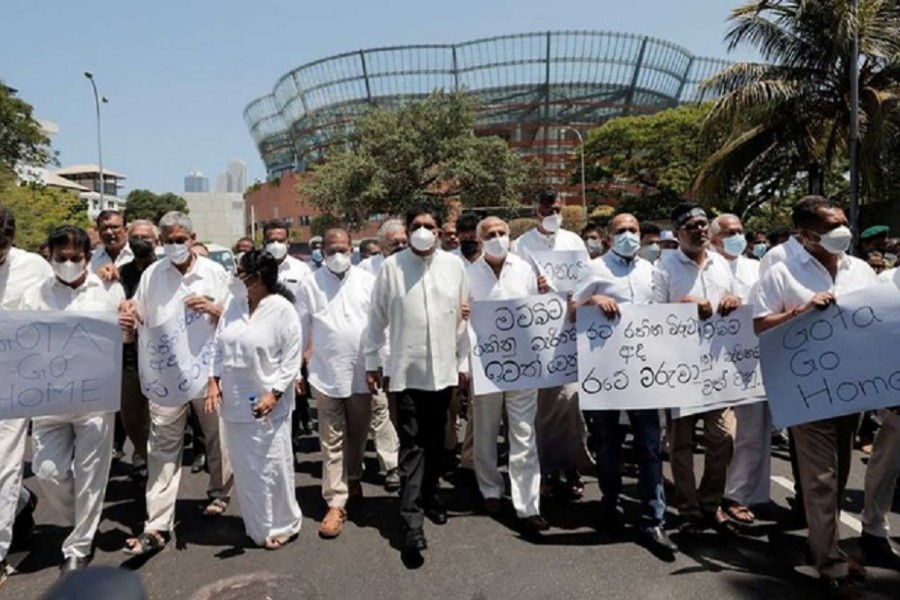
[{"x1": 672, "y1": 305, "x2": 765, "y2": 419}]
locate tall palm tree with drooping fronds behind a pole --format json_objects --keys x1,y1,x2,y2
[{"x1": 694, "y1": 0, "x2": 900, "y2": 202}]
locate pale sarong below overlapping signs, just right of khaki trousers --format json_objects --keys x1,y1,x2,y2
[{"x1": 724, "y1": 402, "x2": 772, "y2": 506}]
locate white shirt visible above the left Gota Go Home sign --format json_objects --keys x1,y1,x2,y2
[{"x1": 22, "y1": 273, "x2": 125, "y2": 313}]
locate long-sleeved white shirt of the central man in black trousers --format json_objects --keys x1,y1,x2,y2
[{"x1": 364, "y1": 250, "x2": 469, "y2": 392}]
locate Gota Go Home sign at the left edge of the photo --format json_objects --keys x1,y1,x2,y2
[{"x1": 0, "y1": 311, "x2": 122, "y2": 419}]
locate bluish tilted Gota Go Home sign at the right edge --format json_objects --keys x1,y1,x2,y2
[{"x1": 760, "y1": 285, "x2": 900, "y2": 427}]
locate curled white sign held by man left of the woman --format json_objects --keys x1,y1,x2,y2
[{"x1": 138, "y1": 307, "x2": 216, "y2": 407}]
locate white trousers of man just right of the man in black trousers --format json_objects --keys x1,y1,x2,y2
[{"x1": 473, "y1": 390, "x2": 541, "y2": 518}]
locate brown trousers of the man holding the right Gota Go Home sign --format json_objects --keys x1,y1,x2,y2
[{"x1": 791, "y1": 414, "x2": 859, "y2": 578}]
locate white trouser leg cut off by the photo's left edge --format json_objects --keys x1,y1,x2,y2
[{"x1": 0, "y1": 419, "x2": 28, "y2": 561}]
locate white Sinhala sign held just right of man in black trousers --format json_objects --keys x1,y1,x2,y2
[{"x1": 469, "y1": 294, "x2": 578, "y2": 395}]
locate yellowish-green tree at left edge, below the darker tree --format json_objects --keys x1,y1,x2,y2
[{"x1": 0, "y1": 183, "x2": 91, "y2": 252}]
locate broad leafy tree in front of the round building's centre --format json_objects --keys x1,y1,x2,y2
[{"x1": 298, "y1": 92, "x2": 525, "y2": 226}]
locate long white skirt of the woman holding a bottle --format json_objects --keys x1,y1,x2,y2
[{"x1": 222, "y1": 416, "x2": 303, "y2": 546}]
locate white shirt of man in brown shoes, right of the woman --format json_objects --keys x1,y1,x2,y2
[{"x1": 297, "y1": 266, "x2": 375, "y2": 398}]
